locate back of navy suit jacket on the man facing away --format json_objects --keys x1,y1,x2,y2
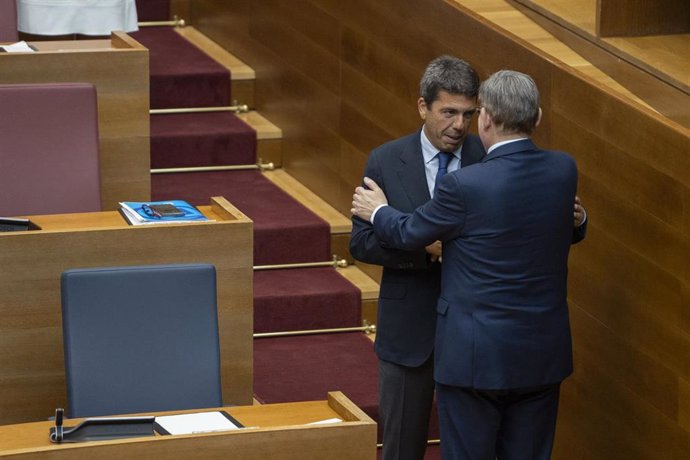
[{"x1": 436, "y1": 140, "x2": 577, "y2": 389}]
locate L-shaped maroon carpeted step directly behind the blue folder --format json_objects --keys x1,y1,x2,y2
[{"x1": 151, "y1": 171, "x2": 332, "y2": 265}]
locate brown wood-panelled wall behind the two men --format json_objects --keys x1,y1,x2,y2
[{"x1": 185, "y1": 0, "x2": 690, "y2": 460}]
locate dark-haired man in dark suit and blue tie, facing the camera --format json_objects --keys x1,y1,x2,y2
[{"x1": 350, "y1": 56, "x2": 484, "y2": 460}]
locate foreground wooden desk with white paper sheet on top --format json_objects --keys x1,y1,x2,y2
[{"x1": 0, "y1": 392, "x2": 376, "y2": 460}]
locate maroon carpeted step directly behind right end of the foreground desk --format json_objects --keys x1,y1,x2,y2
[{"x1": 254, "y1": 332, "x2": 380, "y2": 439}]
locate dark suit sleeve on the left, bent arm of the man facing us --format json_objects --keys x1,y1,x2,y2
[{"x1": 350, "y1": 151, "x2": 431, "y2": 269}]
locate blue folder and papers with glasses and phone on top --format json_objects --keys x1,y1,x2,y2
[{"x1": 120, "y1": 200, "x2": 213, "y2": 225}]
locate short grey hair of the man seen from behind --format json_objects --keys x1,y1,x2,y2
[{"x1": 479, "y1": 70, "x2": 539, "y2": 134}]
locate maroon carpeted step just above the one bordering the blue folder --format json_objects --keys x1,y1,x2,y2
[{"x1": 151, "y1": 112, "x2": 256, "y2": 169}]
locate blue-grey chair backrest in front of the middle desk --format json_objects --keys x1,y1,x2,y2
[{"x1": 61, "y1": 264, "x2": 223, "y2": 417}]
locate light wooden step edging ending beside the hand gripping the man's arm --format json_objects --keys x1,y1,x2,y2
[{"x1": 264, "y1": 169, "x2": 352, "y2": 235}]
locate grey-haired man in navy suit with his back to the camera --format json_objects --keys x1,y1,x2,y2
[{"x1": 352, "y1": 71, "x2": 577, "y2": 459}]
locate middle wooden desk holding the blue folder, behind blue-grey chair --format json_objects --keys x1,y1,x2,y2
[{"x1": 0, "y1": 198, "x2": 253, "y2": 424}]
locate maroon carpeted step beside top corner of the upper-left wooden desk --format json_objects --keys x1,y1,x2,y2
[{"x1": 130, "y1": 27, "x2": 230, "y2": 109}]
